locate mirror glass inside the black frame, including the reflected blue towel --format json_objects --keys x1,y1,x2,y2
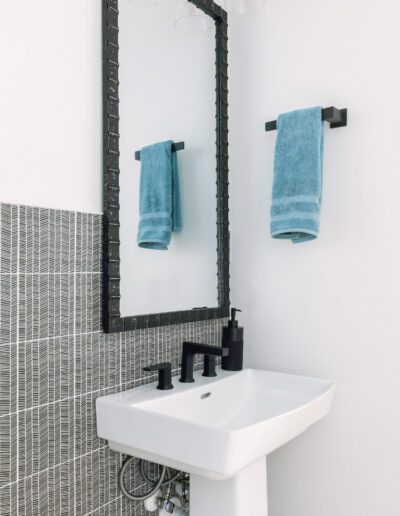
[{"x1": 119, "y1": 0, "x2": 218, "y2": 317}]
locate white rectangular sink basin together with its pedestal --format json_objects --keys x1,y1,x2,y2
[{"x1": 96, "y1": 369, "x2": 335, "y2": 516}]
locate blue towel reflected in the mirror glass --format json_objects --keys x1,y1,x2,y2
[{"x1": 137, "y1": 140, "x2": 182, "y2": 250}]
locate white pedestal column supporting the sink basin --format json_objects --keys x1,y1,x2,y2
[{"x1": 190, "y1": 457, "x2": 268, "y2": 516}]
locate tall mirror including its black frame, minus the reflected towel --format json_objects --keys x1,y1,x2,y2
[{"x1": 103, "y1": 0, "x2": 229, "y2": 332}]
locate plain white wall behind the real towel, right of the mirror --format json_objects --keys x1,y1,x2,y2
[{"x1": 230, "y1": 0, "x2": 400, "y2": 516}]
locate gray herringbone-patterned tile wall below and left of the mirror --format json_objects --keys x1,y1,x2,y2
[{"x1": 0, "y1": 204, "x2": 223, "y2": 516}]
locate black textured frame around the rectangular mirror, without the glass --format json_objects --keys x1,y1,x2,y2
[{"x1": 103, "y1": 0, "x2": 229, "y2": 333}]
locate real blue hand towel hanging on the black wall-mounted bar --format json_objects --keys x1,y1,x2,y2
[{"x1": 271, "y1": 107, "x2": 324, "y2": 244}]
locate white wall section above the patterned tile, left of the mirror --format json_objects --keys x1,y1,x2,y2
[{"x1": 0, "y1": 0, "x2": 102, "y2": 213}]
